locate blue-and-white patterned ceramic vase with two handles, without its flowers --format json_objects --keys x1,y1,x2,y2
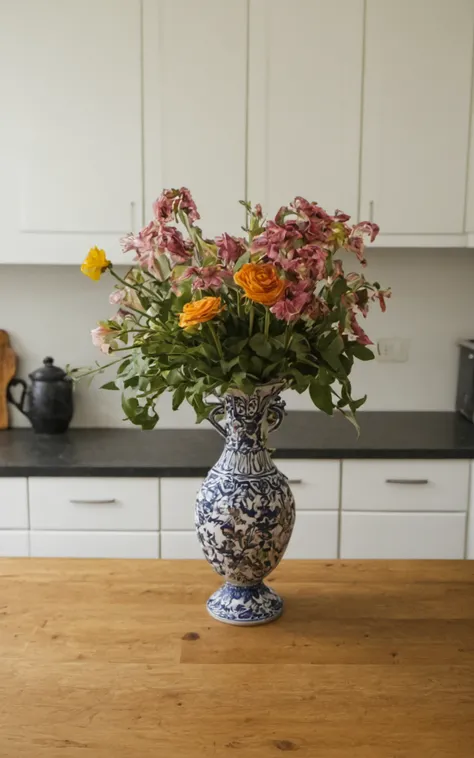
[{"x1": 195, "y1": 383, "x2": 295, "y2": 626}]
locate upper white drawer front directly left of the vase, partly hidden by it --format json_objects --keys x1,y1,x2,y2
[{"x1": 160, "y1": 477, "x2": 203, "y2": 530}]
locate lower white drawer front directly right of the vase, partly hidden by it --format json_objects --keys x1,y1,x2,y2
[{"x1": 285, "y1": 511, "x2": 338, "y2": 558}]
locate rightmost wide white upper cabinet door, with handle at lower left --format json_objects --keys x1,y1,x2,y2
[{"x1": 361, "y1": 0, "x2": 474, "y2": 238}]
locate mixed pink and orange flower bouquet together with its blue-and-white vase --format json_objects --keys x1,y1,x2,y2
[{"x1": 79, "y1": 188, "x2": 390, "y2": 625}]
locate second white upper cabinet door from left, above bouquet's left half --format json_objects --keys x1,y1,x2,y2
[{"x1": 144, "y1": 0, "x2": 247, "y2": 236}]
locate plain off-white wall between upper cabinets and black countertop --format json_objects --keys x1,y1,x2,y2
[{"x1": 0, "y1": 249, "x2": 474, "y2": 428}]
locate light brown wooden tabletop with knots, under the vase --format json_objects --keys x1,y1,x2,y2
[{"x1": 0, "y1": 559, "x2": 474, "y2": 758}]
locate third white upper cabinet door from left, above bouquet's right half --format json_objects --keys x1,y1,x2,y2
[{"x1": 248, "y1": 0, "x2": 363, "y2": 224}]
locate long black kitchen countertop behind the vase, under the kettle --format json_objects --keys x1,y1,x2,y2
[{"x1": 0, "y1": 411, "x2": 474, "y2": 476}]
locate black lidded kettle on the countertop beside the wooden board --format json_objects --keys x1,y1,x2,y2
[{"x1": 7, "y1": 358, "x2": 74, "y2": 434}]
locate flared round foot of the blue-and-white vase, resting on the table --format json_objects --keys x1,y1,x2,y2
[{"x1": 207, "y1": 582, "x2": 283, "y2": 626}]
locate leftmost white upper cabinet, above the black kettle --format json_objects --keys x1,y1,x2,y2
[{"x1": 0, "y1": 0, "x2": 142, "y2": 263}]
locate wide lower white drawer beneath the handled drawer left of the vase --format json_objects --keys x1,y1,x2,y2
[{"x1": 30, "y1": 531, "x2": 159, "y2": 558}]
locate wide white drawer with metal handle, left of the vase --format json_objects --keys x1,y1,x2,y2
[{"x1": 29, "y1": 477, "x2": 159, "y2": 531}]
